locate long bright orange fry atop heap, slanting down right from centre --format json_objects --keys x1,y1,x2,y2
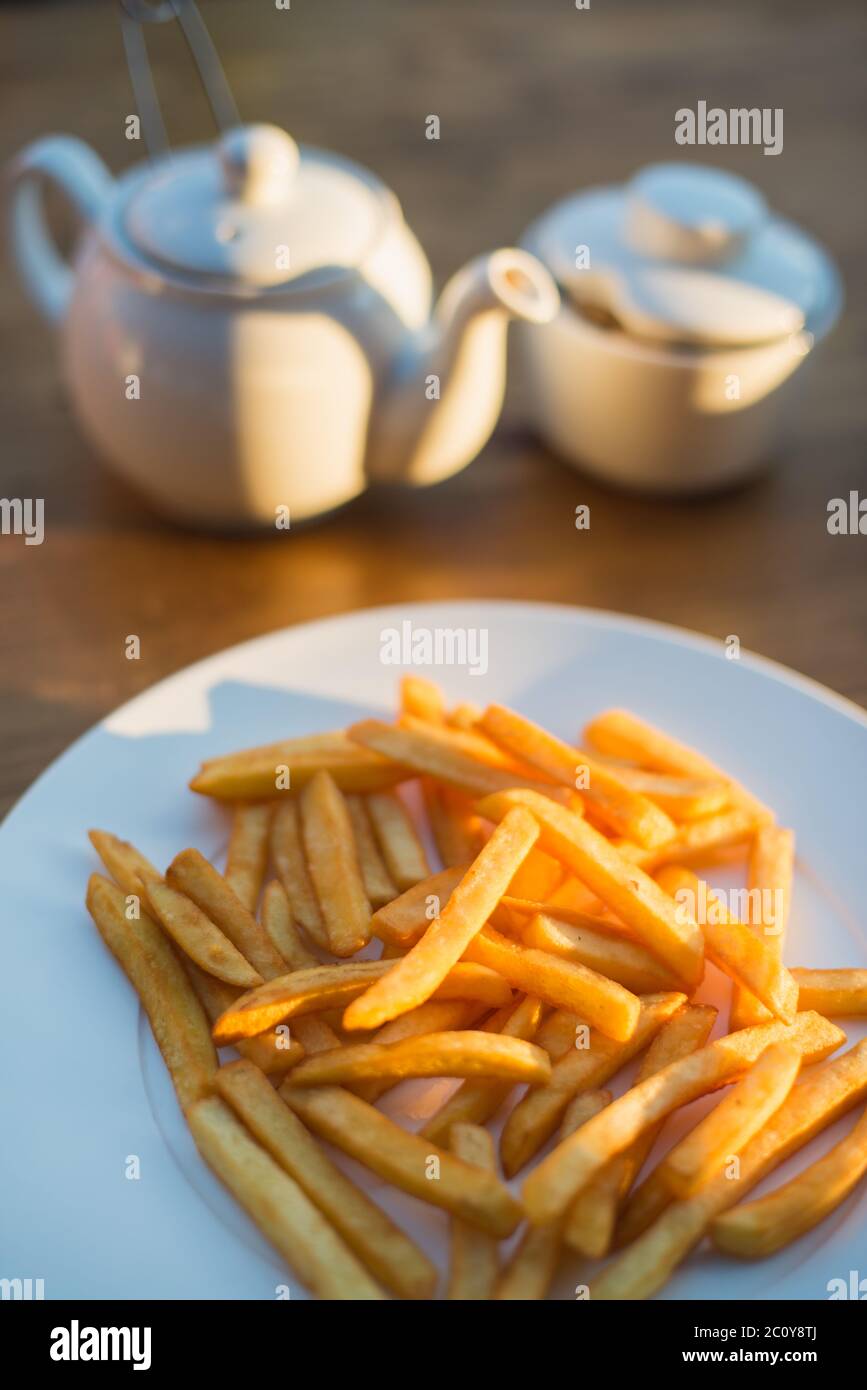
[{"x1": 477, "y1": 791, "x2": 704, "y2": 990}]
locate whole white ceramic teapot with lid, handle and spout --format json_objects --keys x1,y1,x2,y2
[{"x1": 11, "y1": 125, "x2": 559, "y2": 527}]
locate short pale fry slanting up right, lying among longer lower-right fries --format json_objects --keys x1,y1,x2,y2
[{"x1": 660, "y1": 1043, "x2": 800, "y2": 1197}]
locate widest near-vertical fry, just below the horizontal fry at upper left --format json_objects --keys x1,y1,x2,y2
[{"x1": 300, "y1": 773, "x2": 371, "y2": 956}]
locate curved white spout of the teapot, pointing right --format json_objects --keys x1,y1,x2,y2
[{"x1": 368, "y1": 247, "x2": 560, "y2": 487}]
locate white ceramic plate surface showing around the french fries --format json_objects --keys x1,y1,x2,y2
[{"x1": 0, "y1": 600, "x2": 867, "y2": 1300}]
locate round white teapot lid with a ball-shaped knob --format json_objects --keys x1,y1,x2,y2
[{"x1": 124, "y1": 125, "x2": 389, "y2": 286}]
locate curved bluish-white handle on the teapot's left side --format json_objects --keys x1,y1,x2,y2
[{"x1": 8, "y1": 135, "x2": 114, "y2": 322}]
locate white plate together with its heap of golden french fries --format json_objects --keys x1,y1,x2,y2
[{"x1": 0, "y1": 602, "x2": 867, "y2": 1302}]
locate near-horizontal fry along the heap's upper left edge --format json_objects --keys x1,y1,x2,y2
[{"x1": 190, "y1": 730, "x2": 407, "y2": 801}]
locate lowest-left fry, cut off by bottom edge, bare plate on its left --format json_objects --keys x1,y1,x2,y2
[{"x1": 188, "y1": 1087, "x2": 385, "y2": 1300}]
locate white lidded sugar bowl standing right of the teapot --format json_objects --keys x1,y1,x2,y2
[{"x1": 517, "y1": 163, "x2": 842, "y2": 493}]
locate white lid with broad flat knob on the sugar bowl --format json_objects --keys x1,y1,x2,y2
[{"x1": 527, "y1": 163, "x2": 841, "y2": 346}]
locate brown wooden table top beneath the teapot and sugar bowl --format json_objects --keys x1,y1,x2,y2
[{"x1": 0, "y1": 0, "x2": 867, "y2": 808}]
